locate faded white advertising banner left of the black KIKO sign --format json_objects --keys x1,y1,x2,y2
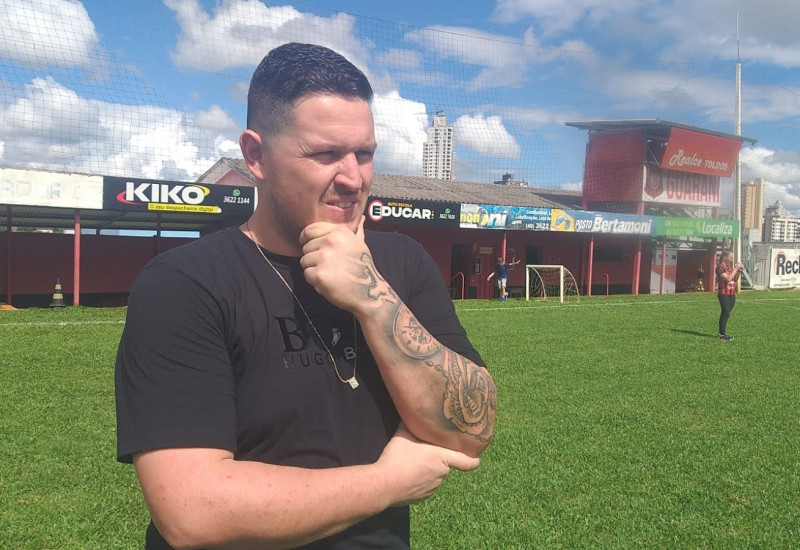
[{"x1": 0, "y1": 168, "x2": 103, "y2": 210}]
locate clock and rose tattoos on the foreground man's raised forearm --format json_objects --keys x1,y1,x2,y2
[{"x1": 393, "y1": 305, "x2": 497, "y2": 442}]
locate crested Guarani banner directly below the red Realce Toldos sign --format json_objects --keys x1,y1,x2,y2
[{"x1": 642, "y1": 166, "x2": 720, "y2": 206}]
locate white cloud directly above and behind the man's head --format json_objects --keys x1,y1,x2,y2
[{"x1": 164, "y1": 0, "x2": 367, "y2": 71}]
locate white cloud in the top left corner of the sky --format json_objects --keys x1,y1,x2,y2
[{"x1": 0, "y1": 0, "x2": 98, "y2": 69}]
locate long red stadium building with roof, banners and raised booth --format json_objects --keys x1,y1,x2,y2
[{"x1": 0, "y1": 120, "x2": 753, "y2": 307}]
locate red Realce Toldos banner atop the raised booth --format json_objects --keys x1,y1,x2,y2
[{"x1": 660, "y1": 128, "x2": 742, "y2": 178}]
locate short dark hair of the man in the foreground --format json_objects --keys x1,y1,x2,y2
[{"x1": 247, "y1": 42, "x2": 372, "y2": 135}]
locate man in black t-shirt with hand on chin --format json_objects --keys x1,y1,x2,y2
[{"x1": 116, "y1": 44, "x2": 497, "y2": 550}]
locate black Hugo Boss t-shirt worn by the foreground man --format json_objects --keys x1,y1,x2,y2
[{"x1": 116, "y1": 227, "x2": 483, "y2": 550}]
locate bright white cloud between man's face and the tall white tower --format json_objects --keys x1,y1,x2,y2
[{"x1": 372, "y1": 91, "x2": 428, "y2": 176}]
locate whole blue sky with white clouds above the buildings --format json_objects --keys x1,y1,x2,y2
[{"x1": 0, "y1": 0, "x2": 800, "y2": 215}]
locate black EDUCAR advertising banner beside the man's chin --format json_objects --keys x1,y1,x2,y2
[{"x1": 367, "y1": 197, "x2": 461, "y2": 227}]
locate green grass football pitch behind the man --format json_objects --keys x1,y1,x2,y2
[{"x1": 0, "y1": 292, "x2": 800, "y2": 550}]
